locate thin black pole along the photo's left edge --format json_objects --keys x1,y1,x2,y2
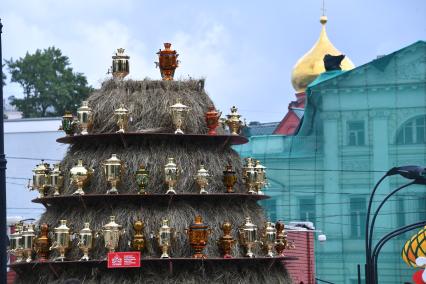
[{"x1": 0, "y1": 19, "x2": 7, "y2": 283}]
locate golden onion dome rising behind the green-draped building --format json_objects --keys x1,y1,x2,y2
[{"x1": 291, "y1": 16, "x2": 355, "y2": 93}]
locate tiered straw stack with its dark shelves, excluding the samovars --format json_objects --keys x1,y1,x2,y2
[{"x1": 12, "y1": 79, "x2": 291, "y2": 284}]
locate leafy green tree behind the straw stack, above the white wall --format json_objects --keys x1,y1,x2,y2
[{"x1": 6, "y1": 47, "x2": 92, "y2": 117}]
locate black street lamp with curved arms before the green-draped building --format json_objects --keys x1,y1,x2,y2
[{"x1": 365, "y1": 166, "x2": 426, "y2": 284}]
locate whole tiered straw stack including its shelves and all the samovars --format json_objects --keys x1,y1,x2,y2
[{"x1": 10, "y1": 44, "x2": 291, "y2": 283}]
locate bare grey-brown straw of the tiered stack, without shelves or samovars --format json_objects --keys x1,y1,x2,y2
[{"x1": 17, "y1": 80, "x2": 291, "y2": 284}]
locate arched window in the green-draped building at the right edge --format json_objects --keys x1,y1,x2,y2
[{"x1": 396, "y1": 115, "x2": 426, "y2": 144}]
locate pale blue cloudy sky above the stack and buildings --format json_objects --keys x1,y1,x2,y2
[{"x1": 0, "y1": 0, "x2": 426, "y2": 122}]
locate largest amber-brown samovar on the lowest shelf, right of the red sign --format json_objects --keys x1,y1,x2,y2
[{"x1": 185, "y1": 215, "x2": 211, "y2": 258}]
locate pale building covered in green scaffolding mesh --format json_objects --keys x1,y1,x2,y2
[{"x1": 236, "y1": 37, "x2": 426, "y2": 284}]
